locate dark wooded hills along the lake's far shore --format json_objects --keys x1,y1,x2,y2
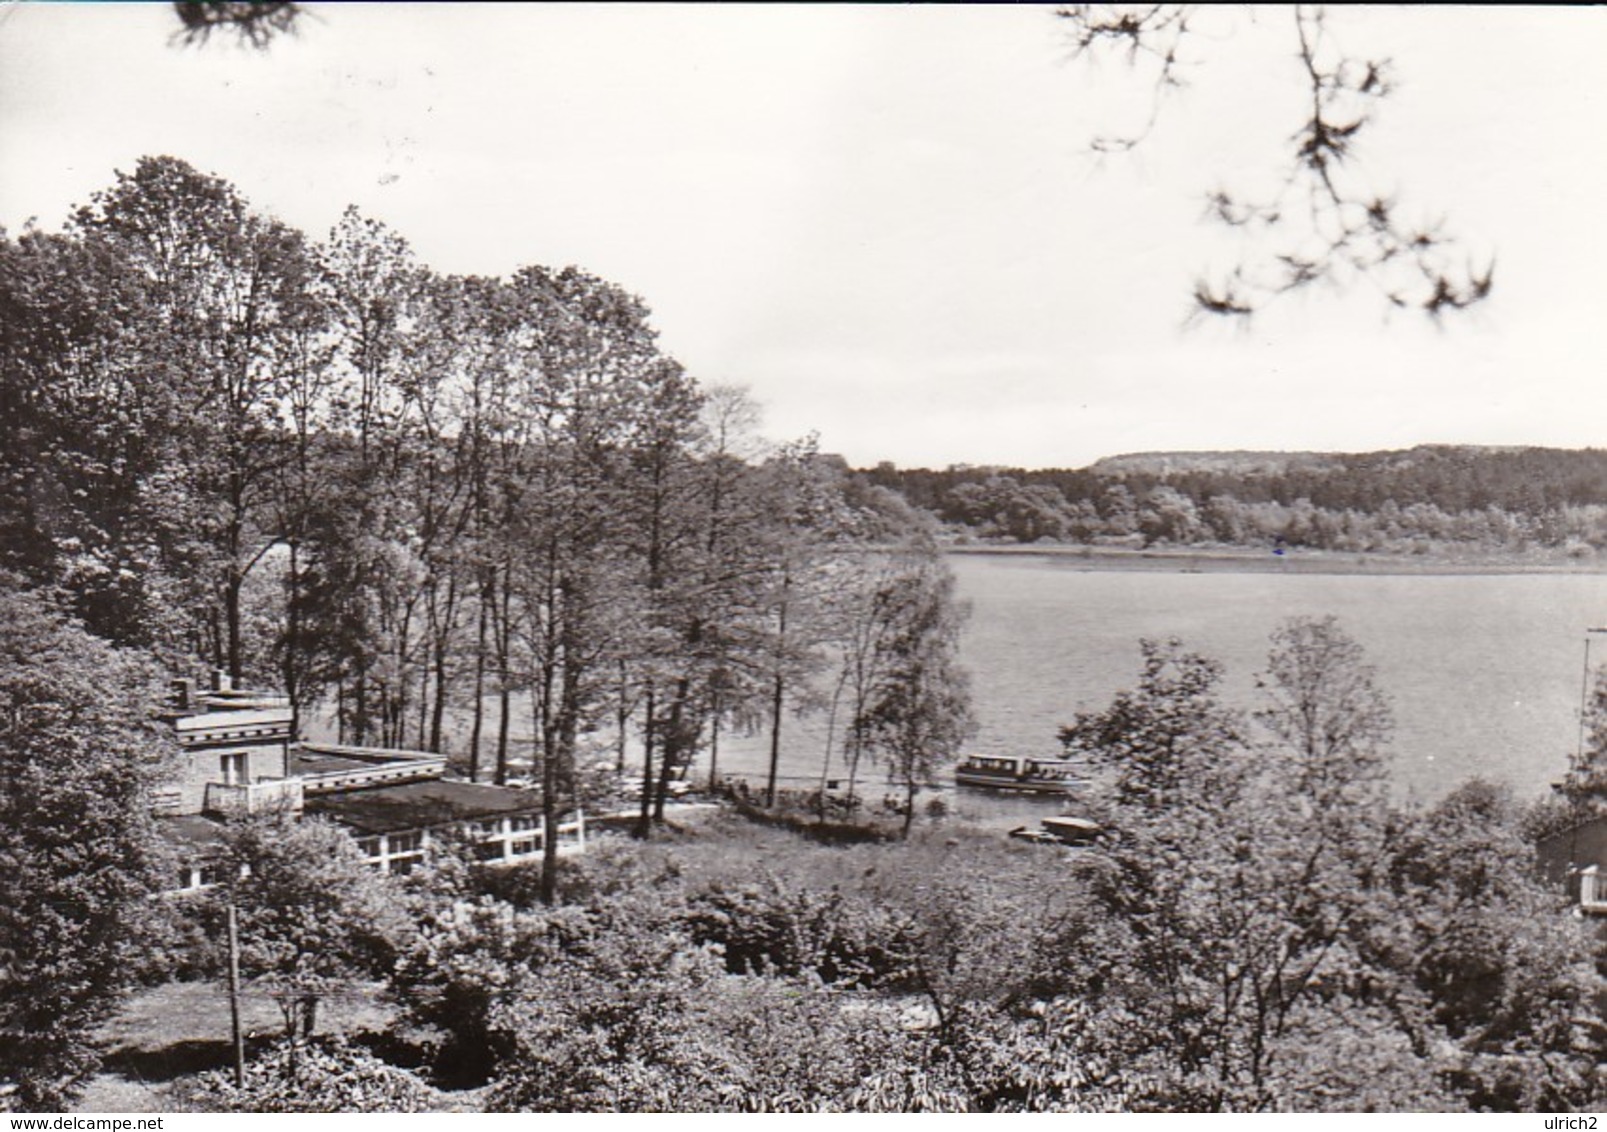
[{"x1": 861, "y1": 445, "x2": 1607, "y2": 560}]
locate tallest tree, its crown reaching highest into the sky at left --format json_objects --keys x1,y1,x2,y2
[{"x1": 74, "y1": 158, "x2": 320, "y2": 679}]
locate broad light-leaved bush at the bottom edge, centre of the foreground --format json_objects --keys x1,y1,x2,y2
[{"x1": 489, "y1": 934, "x2": 955, "y2": 1113}]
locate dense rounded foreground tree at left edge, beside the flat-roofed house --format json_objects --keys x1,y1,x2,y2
[{"x1": 0, "y1": 576, "x2": 170, "y2": 1111}]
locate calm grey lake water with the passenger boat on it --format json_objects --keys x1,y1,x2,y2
[{"x1": 716, "y1": 553, "x2": 1607, "y2": 817}]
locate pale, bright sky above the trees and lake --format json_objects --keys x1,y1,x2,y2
[{"x1": 0, "y1": 0, "x2": 1607, "y2": 468}]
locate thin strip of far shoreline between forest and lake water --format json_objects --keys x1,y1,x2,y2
[{"x1": 942, "y1": 543, "x2": 1607, "y2": 576}]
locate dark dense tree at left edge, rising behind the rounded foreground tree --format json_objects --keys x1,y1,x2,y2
[{"x1": 0, "y1": 232, "x2": 185, "y2": 646}]
